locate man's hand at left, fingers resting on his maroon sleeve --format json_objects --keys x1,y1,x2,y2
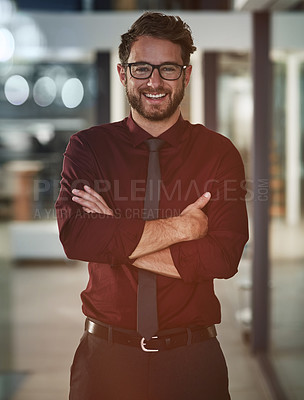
[{"x1": 72, "y1": 185, "x2": 114, "y2": 216}]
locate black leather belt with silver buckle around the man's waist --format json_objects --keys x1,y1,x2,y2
[{"x1": 85, "y1": 318, "x2": 216, "y2": 352}]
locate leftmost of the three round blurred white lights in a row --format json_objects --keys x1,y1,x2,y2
[{"x1": 4, "y1": 75, "x2": 30, "y2": 106}]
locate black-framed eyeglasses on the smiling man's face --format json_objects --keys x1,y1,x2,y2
[{"x1": 125, "y1": 62, "x2": 187, "y2": 81}]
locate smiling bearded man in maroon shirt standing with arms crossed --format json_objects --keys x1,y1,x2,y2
[{"x1": 56, "y1": 13, "x2": 248, "y2": 400}]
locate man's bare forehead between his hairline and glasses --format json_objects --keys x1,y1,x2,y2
[{"x1": 128, "y1": 36, "x2": 183, "y2": 64}]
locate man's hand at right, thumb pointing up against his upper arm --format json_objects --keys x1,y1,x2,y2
[{"x1": 180, "y1": 192, "x2": 211, "y2": 240}]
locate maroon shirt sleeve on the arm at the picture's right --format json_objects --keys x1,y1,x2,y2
[{"x1": 170, "y1": 145, "x2": 248, "y2": 282}]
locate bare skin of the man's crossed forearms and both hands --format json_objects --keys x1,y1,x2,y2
[{"x1": 72, "y1": 185, "x2": 211, "y2": 278}]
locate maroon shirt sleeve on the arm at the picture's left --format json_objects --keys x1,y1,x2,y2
[{"x1": 55, "y1": 134, "x2": 145, "y2": 265}]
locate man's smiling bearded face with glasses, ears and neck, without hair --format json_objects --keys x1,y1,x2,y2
[{"x1": 118, "y1": 36, "x2": 191, "y2": 121}]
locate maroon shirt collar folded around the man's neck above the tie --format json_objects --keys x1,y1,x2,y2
[{"x1": 126, "y1": 113, "x2": 186, "y2": 147}]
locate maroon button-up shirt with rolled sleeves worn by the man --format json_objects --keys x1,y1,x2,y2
[{"x1": 56, "y1": 116, "x2": 248, "y2": 329}]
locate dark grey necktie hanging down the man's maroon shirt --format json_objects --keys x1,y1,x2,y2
[{"x1": 137, "y1": 139, "x2": 164, "y2": 340}]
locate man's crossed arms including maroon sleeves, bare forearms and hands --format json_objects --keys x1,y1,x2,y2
[{"x1": 56, "y1": 135, "x2": 248, "y2": 283}]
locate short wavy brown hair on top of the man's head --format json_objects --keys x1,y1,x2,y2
[{"x1": 119, "y1": 11, "x2": 196, "y2": 65}]
